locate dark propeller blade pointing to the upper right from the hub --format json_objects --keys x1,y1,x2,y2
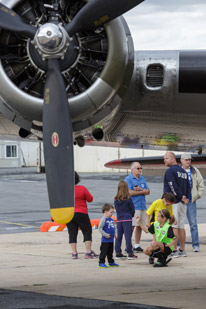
[{"x1": 65, "y1": 0, "x2": 144, "y2": 37}]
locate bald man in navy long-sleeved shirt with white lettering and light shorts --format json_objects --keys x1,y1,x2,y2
[{"x1": 163, "y1": 151, "x2": 191, "y2": 257}]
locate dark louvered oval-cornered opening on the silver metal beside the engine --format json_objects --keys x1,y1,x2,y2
[{"x1": 146, "y1": 64, "x2": 164, "y2": 88}]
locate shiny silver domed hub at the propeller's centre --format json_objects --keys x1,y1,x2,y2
[{"x1": 32, "y1": 23, "x2": 71, "y2": 60}]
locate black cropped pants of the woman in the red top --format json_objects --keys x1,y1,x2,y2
[{"x1": 67, "y1": 212, "x2": 92, "y2": 244}]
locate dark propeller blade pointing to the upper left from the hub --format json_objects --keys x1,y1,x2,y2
[{"x1": 0, "y1": 3, "x2": 36, "y2": 39}]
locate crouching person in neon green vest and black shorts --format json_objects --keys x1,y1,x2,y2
[{"x1": 136, "y1": 209, "x2": 176, "y2": 267}]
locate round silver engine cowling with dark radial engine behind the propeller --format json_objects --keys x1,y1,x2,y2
[{"x1": 0, "y1": 0, "x2": 134, "y2": 135}]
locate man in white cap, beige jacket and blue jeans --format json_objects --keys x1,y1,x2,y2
[{"x1": 180, "y1": 153, "x2": 204, "y2": 252}]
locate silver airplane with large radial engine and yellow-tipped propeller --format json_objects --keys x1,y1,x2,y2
[{"x1": 0, "y1": 0, "x2": 206, "y2": 223}]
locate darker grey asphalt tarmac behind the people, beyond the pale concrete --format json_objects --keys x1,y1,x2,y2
[{"x1": 0, "y1": 168, "x2": 206, "y2": 234}]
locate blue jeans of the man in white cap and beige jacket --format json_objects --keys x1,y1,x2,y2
[{"x1": 187, "y1": 202, "x2": 199, "y2": 248}]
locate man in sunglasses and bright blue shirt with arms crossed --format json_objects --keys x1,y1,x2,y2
[{"x1": 125, "y1": 162, "x2": 150, "y2": 252}]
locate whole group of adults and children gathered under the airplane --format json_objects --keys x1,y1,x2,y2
[{"x1": 67, "y1": 152, "x2": 204, "y2": 268}]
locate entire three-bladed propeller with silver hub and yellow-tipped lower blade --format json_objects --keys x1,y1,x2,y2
[{"x1": 0, "y1": 0, "x2": 144, "y2": 223}]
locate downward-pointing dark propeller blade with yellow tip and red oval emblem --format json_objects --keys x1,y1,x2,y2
[{"x1": 43, "y1": 58, "x2": 74, "y2": 223}]
